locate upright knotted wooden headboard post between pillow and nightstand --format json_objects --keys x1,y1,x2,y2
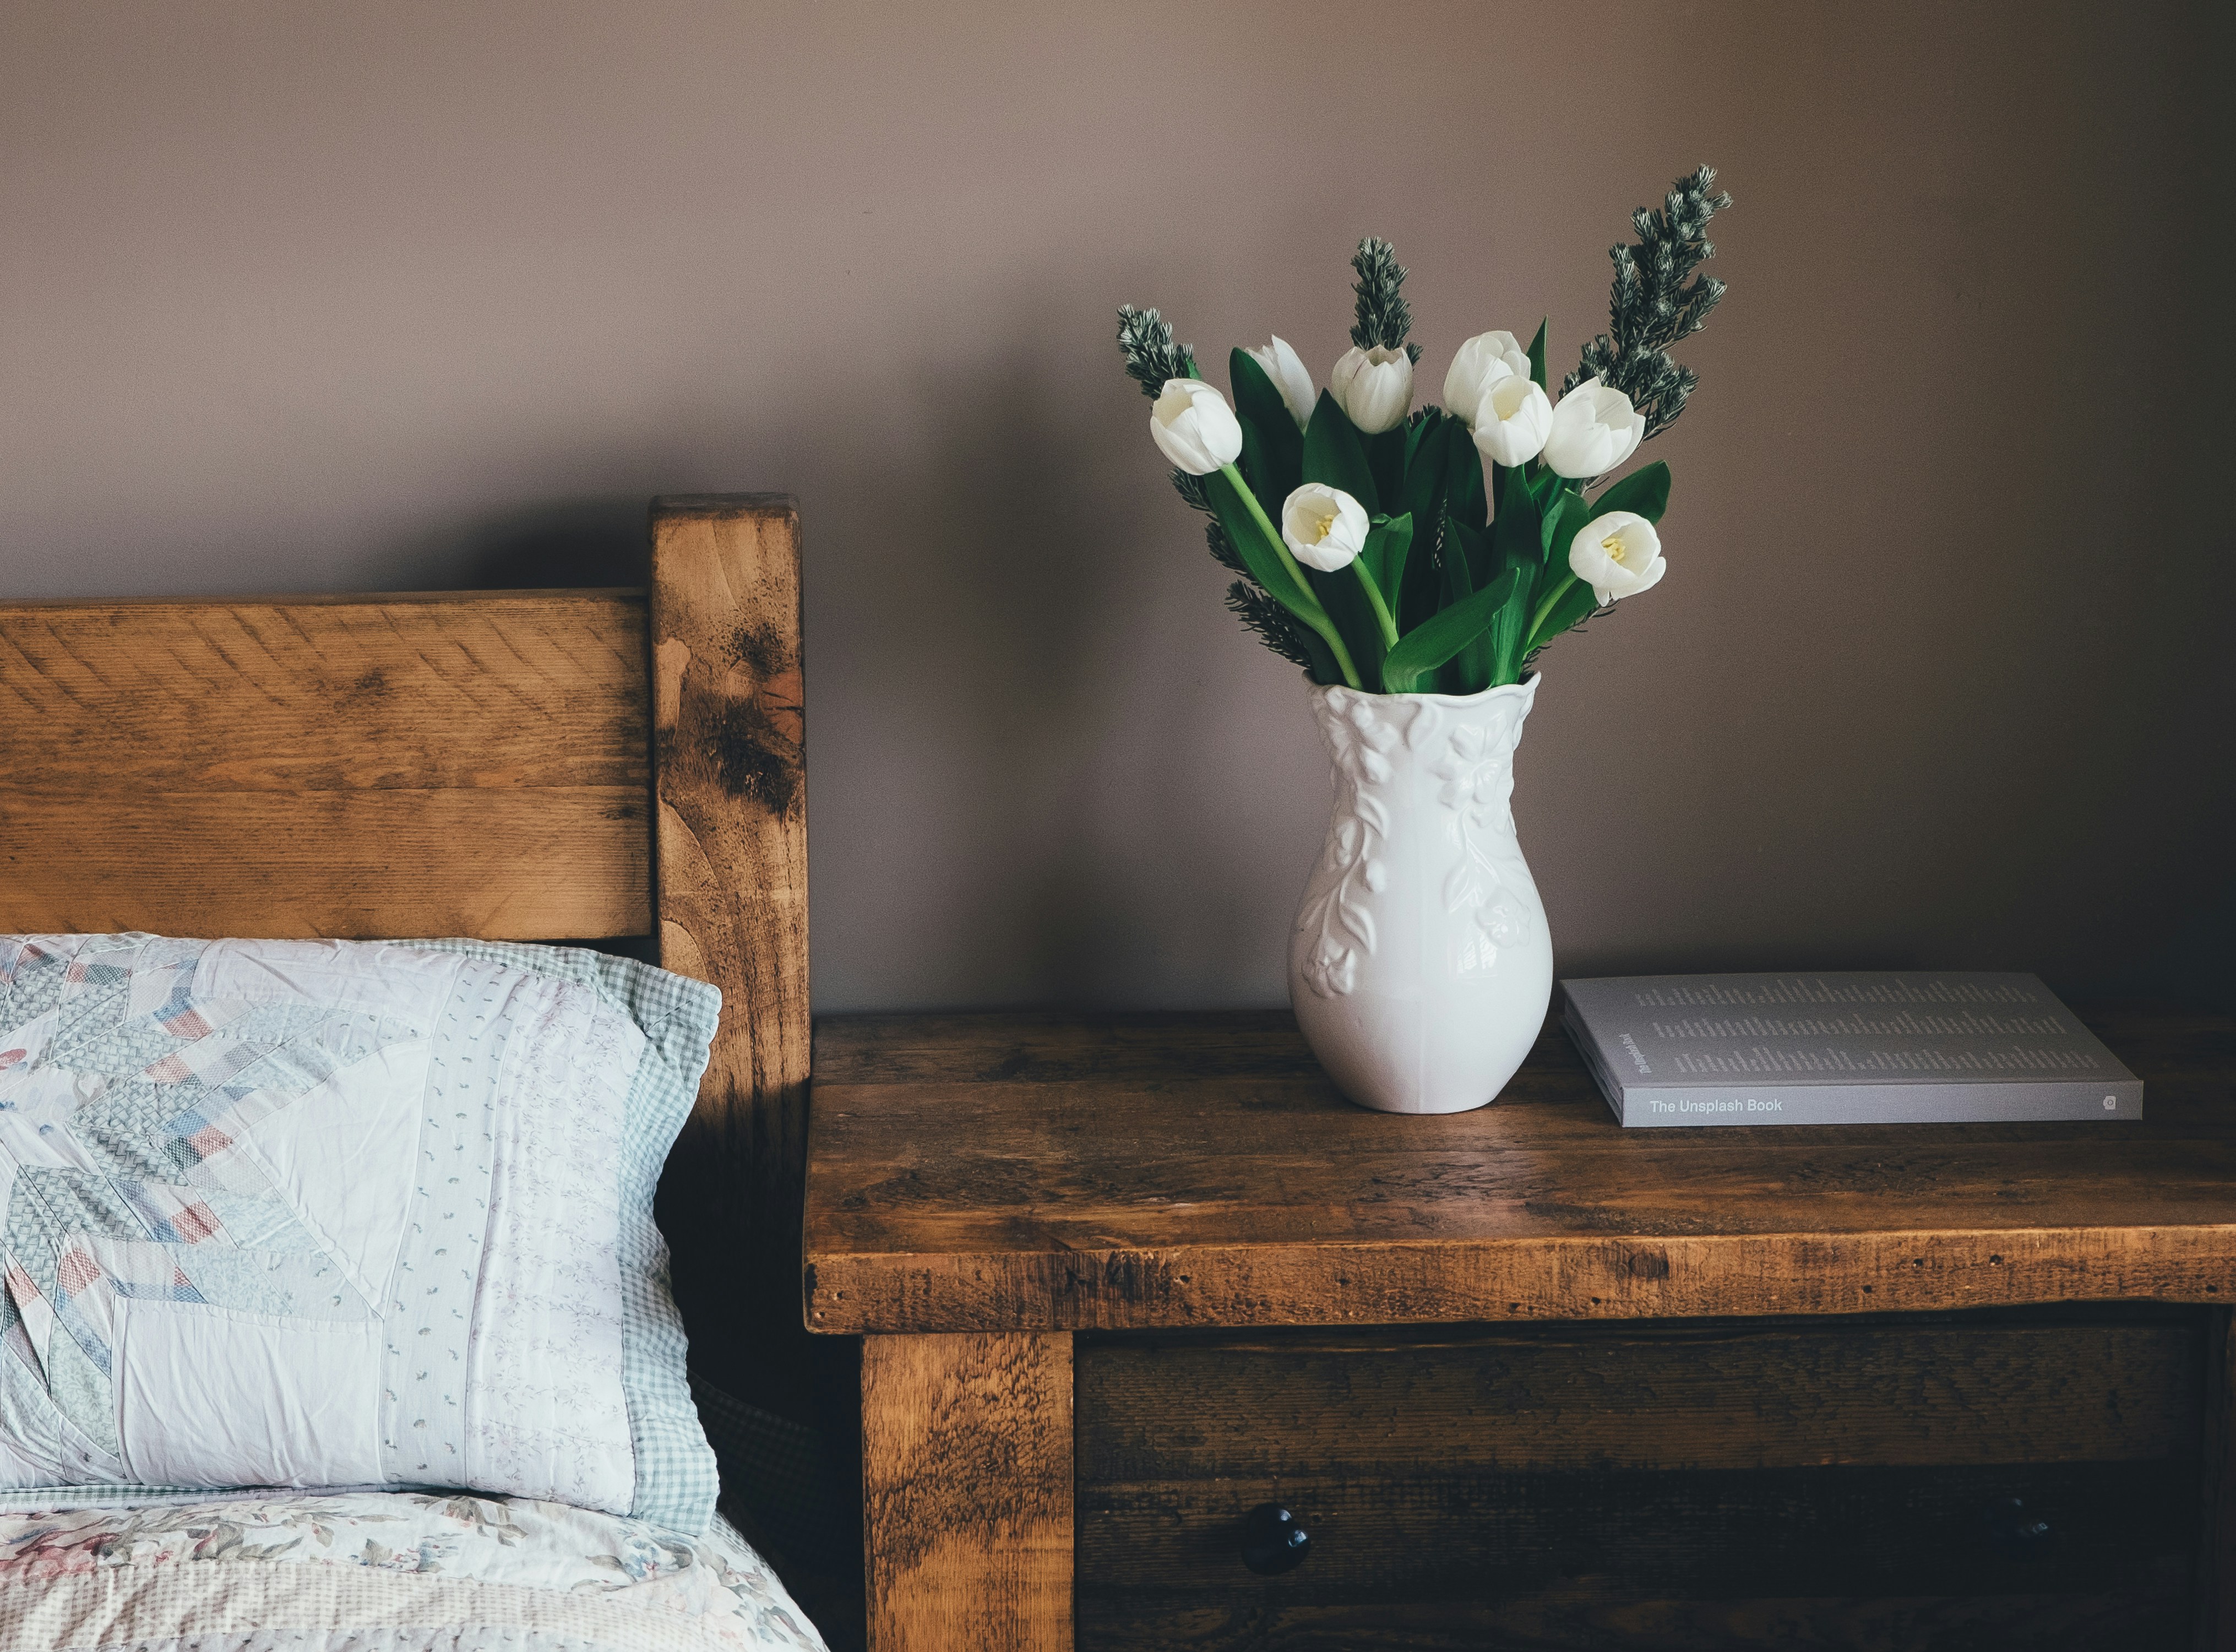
[{"x1": 651, "y1": 494, "x2": 809, "y2": 1409}]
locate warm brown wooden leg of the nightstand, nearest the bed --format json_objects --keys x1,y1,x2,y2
[{"x1": 861, "y1": 1335, "x2": 1073, "y2": 1652}]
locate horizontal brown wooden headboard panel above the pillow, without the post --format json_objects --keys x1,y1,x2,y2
[{"x1": 0, "y1": 590, "x2": 651, "y2": 939}]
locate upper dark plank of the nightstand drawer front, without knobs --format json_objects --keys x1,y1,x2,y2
[{"x1": 1078, "y1": 1310, "x2": 2205, "y2": 1496}]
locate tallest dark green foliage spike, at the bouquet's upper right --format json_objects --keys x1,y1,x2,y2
[{"x1": 1561, "y1": 165, "x2": 1731, "y2": 441}]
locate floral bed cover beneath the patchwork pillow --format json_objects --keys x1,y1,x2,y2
[{"x1": 0, "y1": 1491, "x2": 823, "y2": 1652}]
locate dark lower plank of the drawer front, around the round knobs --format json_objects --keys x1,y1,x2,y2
[{"x1": 1078, "y1": 1460, "x2": 2198, "y2": 1591}]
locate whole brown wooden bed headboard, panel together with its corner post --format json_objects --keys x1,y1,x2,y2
[{"x1": 0, "y1": 494, "x2": 809, "y2": 1393}]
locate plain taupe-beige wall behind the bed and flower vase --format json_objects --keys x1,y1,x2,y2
[{"x1": 0, "y1": 0, "x2": 2236, "y2": 1008}]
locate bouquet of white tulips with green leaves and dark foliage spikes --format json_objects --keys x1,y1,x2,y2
[{"x1": 1118, "y1": 167, "x2": 1731, "y2": 695}]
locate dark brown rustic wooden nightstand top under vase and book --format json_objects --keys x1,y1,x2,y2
[{"x1": 805, "y1": 1010, "x2": 2236, "y2": 1332}]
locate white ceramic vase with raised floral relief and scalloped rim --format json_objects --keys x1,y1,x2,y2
[{"x1": 1288, "y1": 677, "x2": 1552, "y2": 1113}]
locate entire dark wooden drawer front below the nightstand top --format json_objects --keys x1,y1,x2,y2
[{"x1": 1078, "y1": 1308, "x2": 2207, "y2": 1652}]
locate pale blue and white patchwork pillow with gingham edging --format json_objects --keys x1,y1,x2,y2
[{"x1": 0, "y1": 934, "x2": 720, "y2": 1534}]
